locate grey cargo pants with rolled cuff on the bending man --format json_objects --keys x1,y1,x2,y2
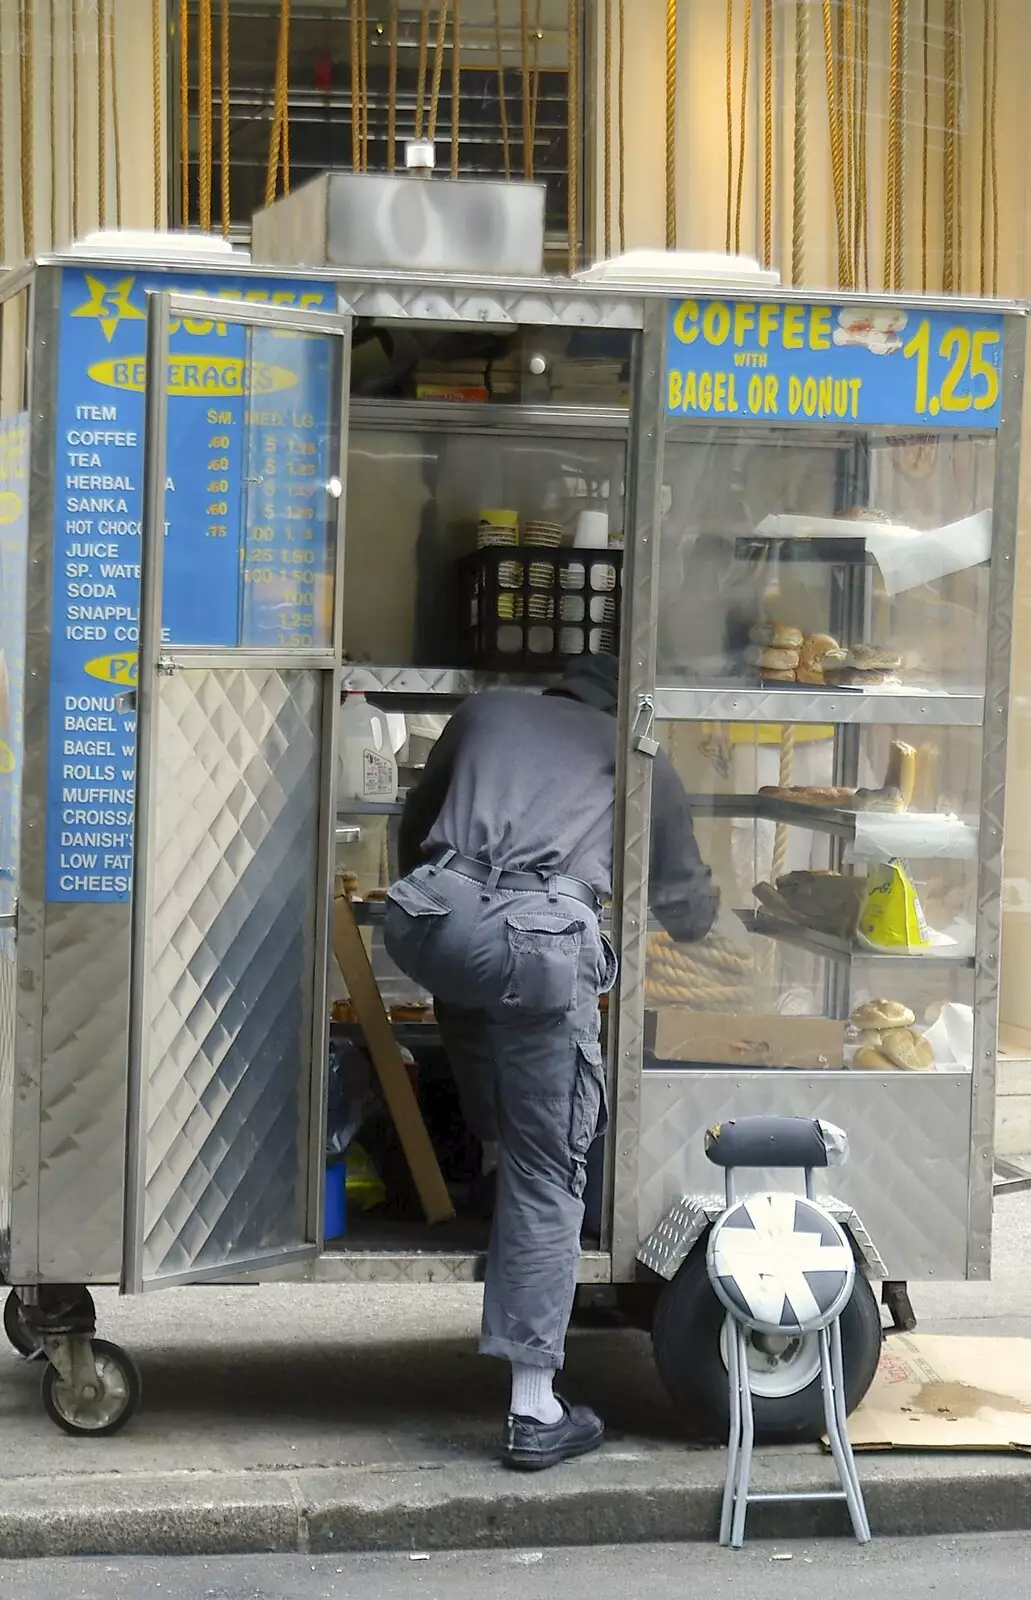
[{"x1": 384, "y1": 866, "x2": 616, "y2": 1368}]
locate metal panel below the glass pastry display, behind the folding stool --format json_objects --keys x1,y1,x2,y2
[{"x1": 640, "y1": 1072, "x2": 970, "y2": 1278}]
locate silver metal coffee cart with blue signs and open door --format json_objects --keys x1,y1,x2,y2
[{"x1": 0, "y1": 176, "x2": 1025, "y2": 1437}]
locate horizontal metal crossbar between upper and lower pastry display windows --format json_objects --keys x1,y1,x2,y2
[{"x1": 655, "y1": 683, "x2": 985, "y2": 728}]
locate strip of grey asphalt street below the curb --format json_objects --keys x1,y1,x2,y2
[{"x1": 0, "y1": 1534, "x2": 1031, "y2": 1600}]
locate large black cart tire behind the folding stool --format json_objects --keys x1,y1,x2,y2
[{"x1": 652, "y1": 1238, "x2": 884, "y2": 1443}]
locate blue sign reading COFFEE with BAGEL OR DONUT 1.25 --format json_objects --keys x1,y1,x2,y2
[{"x1": 666, "y1": 299, "x2": 1002, "y2": 429}]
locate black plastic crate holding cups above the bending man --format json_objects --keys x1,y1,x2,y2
[{"x1": 458, "y1": 546, "x2": 623, "y2": 672}]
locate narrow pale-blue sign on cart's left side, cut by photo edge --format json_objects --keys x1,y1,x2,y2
[{"x1": 0, "y1": 411, "x2": 29, "y2": 955}]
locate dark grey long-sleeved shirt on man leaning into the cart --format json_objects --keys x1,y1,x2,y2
[{"x1": 399, "y1": 690, "x2": 719, "y2": 941}]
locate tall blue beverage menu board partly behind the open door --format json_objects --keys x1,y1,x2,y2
[{"x1": 46, "y1": 269, "x2": 336, "y2": 904}]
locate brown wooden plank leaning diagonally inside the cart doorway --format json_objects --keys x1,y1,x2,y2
[{"x1": 333, "y1": 894, "x2": 455, "y2": 1222}]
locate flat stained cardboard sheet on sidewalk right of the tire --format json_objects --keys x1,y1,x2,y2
[{"x1": 848, "y1": 1334, "x2": 1031, "y2": 1451}]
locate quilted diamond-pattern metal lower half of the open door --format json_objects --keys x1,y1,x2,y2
[{"x1": 142, "y1": 669, "x2": 322, "y2": 1278}]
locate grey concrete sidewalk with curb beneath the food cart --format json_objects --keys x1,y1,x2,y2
[{"x1": 0, "y1": 1194, "x2": 1031, "y2": 1557}]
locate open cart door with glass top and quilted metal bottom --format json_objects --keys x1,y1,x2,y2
[{"x1": 123, "y1": 293, "x2": 351, "y2": 1293}]
